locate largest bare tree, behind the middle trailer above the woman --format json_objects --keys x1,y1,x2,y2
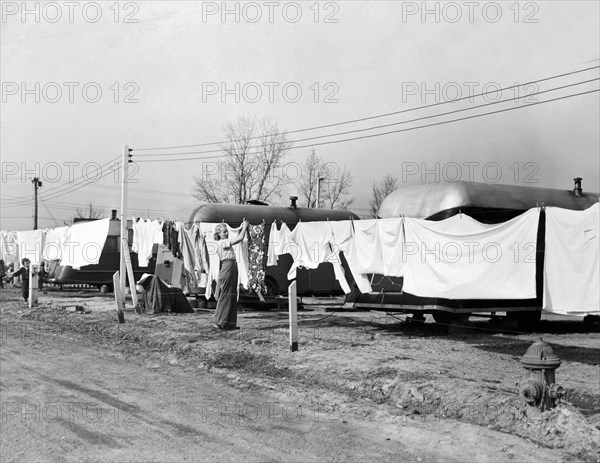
[{"x1": 193, "y1": 117, "x2": 291, "y2": 204}]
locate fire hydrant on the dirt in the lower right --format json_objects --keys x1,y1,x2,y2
[{"x1": 520, "y1": 338, "x2": 566, "y2": 411}]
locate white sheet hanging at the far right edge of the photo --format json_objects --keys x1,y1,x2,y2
[{"x1": 543, "y1": 203, "x2": 600, "y2": 315}]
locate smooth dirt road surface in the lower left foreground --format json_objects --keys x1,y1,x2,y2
[{"x1": 1, "y1": 330, "x2": 427, "y2": 462}]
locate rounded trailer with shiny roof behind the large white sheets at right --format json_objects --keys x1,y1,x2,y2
[{"x1": 355, "y1": 178, "x2": 599, "y2": 328}]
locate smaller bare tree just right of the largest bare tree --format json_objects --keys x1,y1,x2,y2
[{"x1": 299, "y1": 149, "x2": 354, "y2": 209}]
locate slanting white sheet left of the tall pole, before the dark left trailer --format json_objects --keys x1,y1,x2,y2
[{"x1": 60, "y1": 219, "x2": 110, "y2": 269}]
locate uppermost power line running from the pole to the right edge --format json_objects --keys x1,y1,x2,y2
[{"x1": 133, "y1": 66, "x2": 600, "y2": 155}]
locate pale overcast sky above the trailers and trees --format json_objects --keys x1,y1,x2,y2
[{"x1": 0, "y1": 1, "x2": 600, "y2": 230}]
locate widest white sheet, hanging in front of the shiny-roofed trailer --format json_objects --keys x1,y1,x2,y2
[{"x1": 403, "y1": 209, "x2": 539, "y2": 299}]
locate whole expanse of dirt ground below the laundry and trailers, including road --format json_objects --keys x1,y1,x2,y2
[{"x1": 0, "y1": 287, "x2": 600, "y2": 462}]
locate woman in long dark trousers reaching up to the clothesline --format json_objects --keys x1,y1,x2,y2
[{"x1": 213, "y1": 219, "x2": 248, "y2": 330}]
